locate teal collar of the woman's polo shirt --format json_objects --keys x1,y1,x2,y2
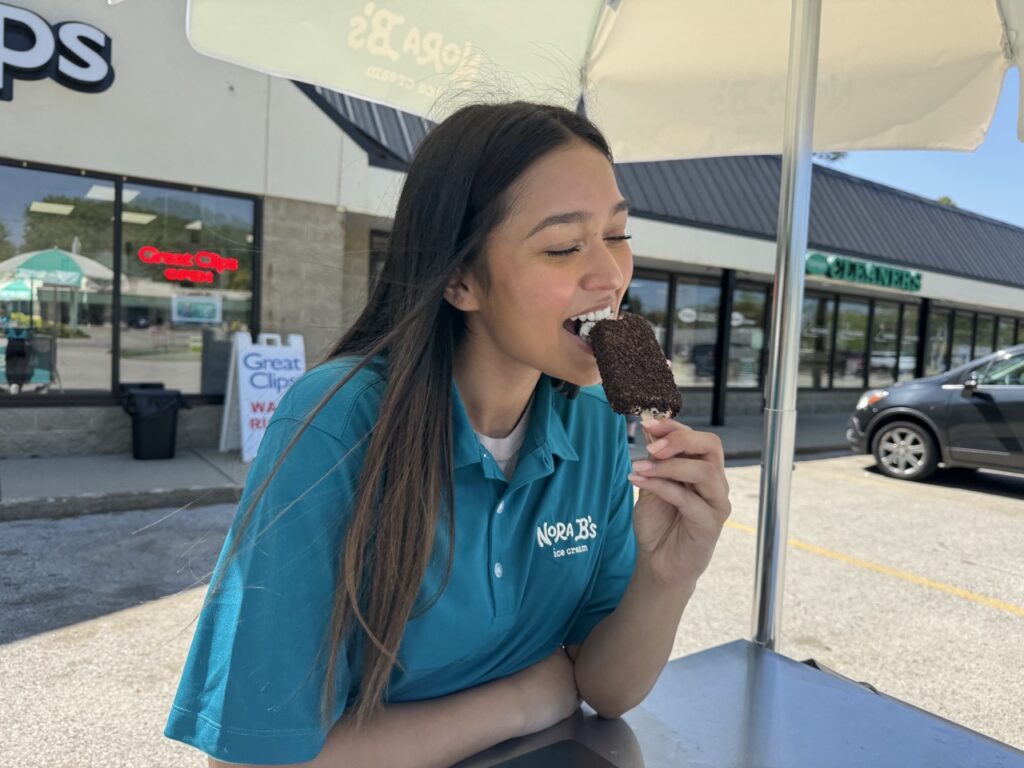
[{"x1": 452, "y1": 374, "x2": 580, "y2": 469}]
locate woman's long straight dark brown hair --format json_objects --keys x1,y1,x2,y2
[{"x1": 207, "y1": 101, "x2": 611, "y2": 729}]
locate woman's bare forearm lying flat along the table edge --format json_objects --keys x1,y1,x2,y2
[{"x1": 310, "y1": 679, "x2": 524, "y2": 768}]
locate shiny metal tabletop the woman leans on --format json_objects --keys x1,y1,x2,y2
[{"x1": 459, "y1": 640, "x2": 1024, "y2": 768}]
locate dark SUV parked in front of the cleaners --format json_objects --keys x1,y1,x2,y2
[{"x1": 846, "y1": 345, "x2": 1024, "y2": 480}]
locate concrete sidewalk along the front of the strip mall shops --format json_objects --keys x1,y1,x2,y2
[{"x1": 0, "y1": 414, "x2": 849, "y2": 522}]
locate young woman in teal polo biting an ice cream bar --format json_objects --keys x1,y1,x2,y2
[{"x1": 166, "y1": 102, "x2": 730, "y2": 768}]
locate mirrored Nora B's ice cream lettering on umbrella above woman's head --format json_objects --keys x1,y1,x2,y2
[{"x1": 347, "y1": 2, "x2": 481, "y2": 97}]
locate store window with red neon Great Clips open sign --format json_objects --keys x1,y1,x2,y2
[{"x1": 120, "y1": 182, "x2": 255, "y2": 395}]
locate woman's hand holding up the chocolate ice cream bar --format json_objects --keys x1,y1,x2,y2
[{"x1": 630, "y1": 419, "x2": 732, "y2": 588}]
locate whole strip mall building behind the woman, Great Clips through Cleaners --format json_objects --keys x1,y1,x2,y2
[{"x1": 0, "y1": 0, "x2": 1024, "y2": 458}]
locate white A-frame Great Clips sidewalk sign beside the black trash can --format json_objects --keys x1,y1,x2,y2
[{"x1": 220, "y1": 333, "x2": 306, "y2": 463}]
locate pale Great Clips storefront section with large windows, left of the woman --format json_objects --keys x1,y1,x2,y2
[{"x1": 0, "y1": 0, "x2": 401, "y2": 459}]
